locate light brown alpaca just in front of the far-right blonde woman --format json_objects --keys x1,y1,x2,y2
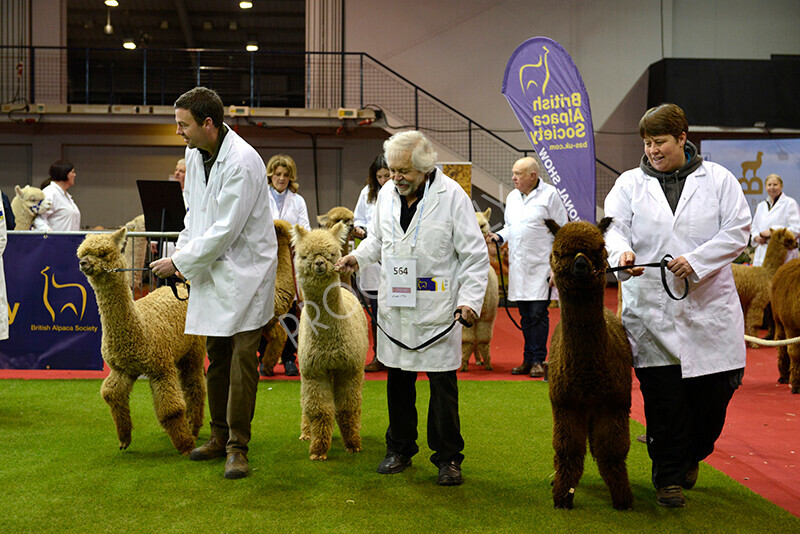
[{"x1": 731, "y1": 228, "x2": 797, "y2": 348}]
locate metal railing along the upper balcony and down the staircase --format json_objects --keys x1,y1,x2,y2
[{"x1": 0, "y1": 46, "x2": 619, "y2": 203}]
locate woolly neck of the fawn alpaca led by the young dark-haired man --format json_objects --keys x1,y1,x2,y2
[{"x1": 92, "y1": 274, "x2": 141, "y2": 341}]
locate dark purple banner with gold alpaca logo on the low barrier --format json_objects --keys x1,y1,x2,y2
[{"x1": 0, "y1": 234, "x2": 103, "y2": 370}]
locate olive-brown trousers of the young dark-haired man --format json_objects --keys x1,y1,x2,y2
[{"x1": 206, "y1": 328, "x2": 261, "y2": 453}]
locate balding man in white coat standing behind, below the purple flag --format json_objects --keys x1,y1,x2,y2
[{"x1": 486, "y1": 157, "x2": 569, "y2": 378}]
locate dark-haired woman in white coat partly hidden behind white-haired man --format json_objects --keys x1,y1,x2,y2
[{"x1": 353, "y1": 154, "x2": 390, "y2": 373}]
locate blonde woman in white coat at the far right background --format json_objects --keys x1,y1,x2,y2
[{"x1": 750, "y1": 174, "x2": 800, "y2": 265}]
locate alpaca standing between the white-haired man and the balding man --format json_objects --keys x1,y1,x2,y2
[{"x1": 461, "y1": 208, "x2": 500, "y2": 371}]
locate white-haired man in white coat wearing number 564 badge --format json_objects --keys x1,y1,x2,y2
[{"x1": 337, "y1": 131, "x2": 489, "y2": 486}]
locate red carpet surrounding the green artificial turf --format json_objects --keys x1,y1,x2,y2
[{"x1": 0, "y1": 288, "x2": 800, "y2": 517}]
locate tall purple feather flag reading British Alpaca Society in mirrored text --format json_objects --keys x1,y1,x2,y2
[{"x1": 503, "y1": 37, "x2": 595, "y2": 222}]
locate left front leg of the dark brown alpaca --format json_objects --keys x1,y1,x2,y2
[{"x1": 553, "y1": 406, "x2": 588, "y2": 510}]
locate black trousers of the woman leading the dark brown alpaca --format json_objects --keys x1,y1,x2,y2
[{"x1": 636, "y1": 365, "x2": 743, "y2": 489}]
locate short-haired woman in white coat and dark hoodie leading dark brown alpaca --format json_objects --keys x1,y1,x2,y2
[{"x1": 605, "y1": 104, "x2": 750, "y2": 507}]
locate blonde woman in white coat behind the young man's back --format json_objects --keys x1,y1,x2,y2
[{"x1": 267, "y1": 154, "x2": 311, "y2": 376}]
